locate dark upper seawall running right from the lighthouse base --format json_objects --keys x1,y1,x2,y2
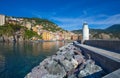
[{"x1": 84, "y1": 40, "x2": 120, "y2": 53}]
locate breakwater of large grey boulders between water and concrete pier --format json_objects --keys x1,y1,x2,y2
[{"x1": 25, "y1": 43, "x2": 104, "y2": 78}]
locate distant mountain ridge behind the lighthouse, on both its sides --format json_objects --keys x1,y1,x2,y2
[{"x1": 72, "y1": 24, "x2": 120, "y2": 39}]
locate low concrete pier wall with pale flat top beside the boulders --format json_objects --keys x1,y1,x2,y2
[{"x1": 74, "y1": 42, "x2": 120, "y2": 78}]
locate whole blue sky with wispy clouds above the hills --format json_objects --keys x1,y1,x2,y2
[{"x1": 0, "y1": 0, "x2": 120, "y2": 30}]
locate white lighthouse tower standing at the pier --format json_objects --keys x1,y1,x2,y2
[{"x1": 82, "y1": 23, "x2": 89, "y2": 42}]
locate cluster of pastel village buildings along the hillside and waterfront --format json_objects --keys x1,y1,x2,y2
[{"x1": 0, "y1": 15, "x2": 78, "y2": 41}]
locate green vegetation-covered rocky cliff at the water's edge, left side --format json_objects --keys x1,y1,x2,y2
[{"x1": 0, "y1": 24, "x2": 42, "y2": 40}]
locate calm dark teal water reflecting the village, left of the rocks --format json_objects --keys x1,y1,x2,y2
[{"x1": 0, "y1": 42, "x2": 64, "y2": 78}]
